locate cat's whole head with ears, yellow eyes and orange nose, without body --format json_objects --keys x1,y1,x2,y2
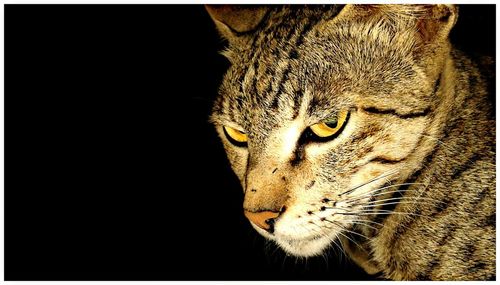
[{"x1": 207, "y1": 5, "x2": 457, "y2": 256}]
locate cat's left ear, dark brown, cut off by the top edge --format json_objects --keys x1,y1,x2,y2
[{"x1": 205, "y1": 5, "x2": 268, "y2": 43}]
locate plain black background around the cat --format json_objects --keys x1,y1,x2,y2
[{"x1": 5, "y1": 5, "x2": 495, "y2": 280}]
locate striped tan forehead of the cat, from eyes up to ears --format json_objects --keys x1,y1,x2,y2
[{"x1": 214, "y1": 6, "x2": 426, "y2": 128}]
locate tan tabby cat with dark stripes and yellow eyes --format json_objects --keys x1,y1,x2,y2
[{"x1": 206, "y1": 5, "x2": 496, "y2": 280}]
